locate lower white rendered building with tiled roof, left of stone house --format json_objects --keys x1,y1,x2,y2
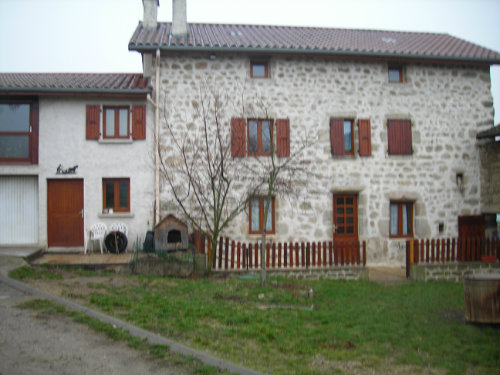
[{"x1": 0, "y1": 74, "x2": 154, "y2": 250}]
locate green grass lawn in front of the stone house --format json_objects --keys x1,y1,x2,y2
[{"x1": 13, "y1": 269, "x2": 500, "y2": 374}]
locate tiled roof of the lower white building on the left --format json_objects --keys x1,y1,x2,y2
[{"x1": 0, "y1": 73, "x2": 151, "y2": 95}]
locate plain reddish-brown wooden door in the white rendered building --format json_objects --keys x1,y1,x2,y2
[{"x1": 47, "y1": 179, "x2": 84, "y2": 247}]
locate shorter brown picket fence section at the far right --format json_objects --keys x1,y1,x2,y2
[{"x1": 406, "y1": 237, "x2": 500, "y2": 280}]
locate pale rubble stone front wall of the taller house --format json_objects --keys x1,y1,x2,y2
[{"x1": 154, "y1": 53, "x2": 493, "y2": 266}]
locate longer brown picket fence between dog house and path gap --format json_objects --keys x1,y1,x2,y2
[{"x1": 207, "y1": 237, "x2": 366, "y2": 271}]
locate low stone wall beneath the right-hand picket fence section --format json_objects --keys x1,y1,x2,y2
[{"x1": 410, "y1": 262, "x2": 500, "y2": 282}]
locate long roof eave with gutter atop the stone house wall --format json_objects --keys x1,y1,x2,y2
[{"x1": 128, "y1": 43, "x2": 500, "y2": 65}]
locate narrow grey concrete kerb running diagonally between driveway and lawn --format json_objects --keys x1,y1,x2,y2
[{"x1": 0, "y1": 267, "x2": 264, "y2": 375}]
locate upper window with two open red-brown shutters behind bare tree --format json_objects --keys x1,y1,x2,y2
[{"x1": 231, "y1": 118, "x2": 290, "y2": 157}]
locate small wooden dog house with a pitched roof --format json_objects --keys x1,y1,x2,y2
[{"x1": 154, "y1": 215, "x2": 189, "y2": 250}]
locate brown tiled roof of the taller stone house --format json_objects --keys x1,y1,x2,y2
[{"x1": 129, "y1": 22, "x2": 500, "y2": 64}]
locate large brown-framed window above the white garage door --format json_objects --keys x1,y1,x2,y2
[{"x1": 0, "y1": 101, "x2": 38, "y2": 164}]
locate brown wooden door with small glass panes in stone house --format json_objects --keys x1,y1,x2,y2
[{"x1": 333, "y1": 194, "x2": 358, "y2": 241}]
